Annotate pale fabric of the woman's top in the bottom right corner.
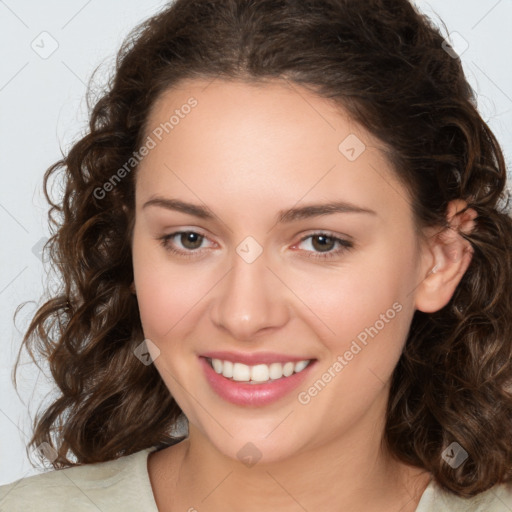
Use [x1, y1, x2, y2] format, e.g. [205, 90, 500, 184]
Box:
[416, 481, 512, 512]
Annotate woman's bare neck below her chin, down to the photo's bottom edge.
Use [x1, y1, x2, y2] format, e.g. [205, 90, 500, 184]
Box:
[155, 398, 430, 512]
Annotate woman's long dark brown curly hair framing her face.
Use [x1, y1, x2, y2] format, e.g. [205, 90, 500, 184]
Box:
[14, 0, 512, 496]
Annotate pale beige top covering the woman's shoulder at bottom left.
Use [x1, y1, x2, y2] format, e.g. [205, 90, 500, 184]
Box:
[0, 447, 157, 512]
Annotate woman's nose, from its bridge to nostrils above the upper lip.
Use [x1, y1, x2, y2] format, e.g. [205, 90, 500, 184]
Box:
[211, 247, 289, 341]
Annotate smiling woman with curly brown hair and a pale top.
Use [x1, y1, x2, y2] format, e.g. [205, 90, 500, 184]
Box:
[0, 0, 512, 512]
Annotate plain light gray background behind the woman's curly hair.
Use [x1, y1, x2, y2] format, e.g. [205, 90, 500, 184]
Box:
[0, 0, 512, 485]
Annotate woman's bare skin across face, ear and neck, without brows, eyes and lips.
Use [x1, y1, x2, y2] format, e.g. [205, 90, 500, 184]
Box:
[132, 80, 475, 512]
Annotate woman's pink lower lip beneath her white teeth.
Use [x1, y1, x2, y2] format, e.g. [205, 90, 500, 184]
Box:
[199, 357, 316, 406]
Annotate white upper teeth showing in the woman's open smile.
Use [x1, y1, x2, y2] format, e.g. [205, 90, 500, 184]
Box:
[211, 359, 310, 383]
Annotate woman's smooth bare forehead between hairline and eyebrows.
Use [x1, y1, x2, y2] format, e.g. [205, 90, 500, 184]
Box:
[137, 79, 406, 222]
